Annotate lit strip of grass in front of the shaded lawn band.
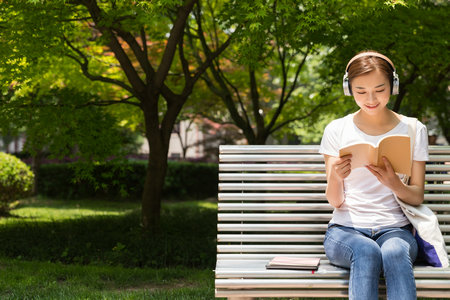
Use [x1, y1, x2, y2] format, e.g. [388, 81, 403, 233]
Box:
[0, 258, 214, 299]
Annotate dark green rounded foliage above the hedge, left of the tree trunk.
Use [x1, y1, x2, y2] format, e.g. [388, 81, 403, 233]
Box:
[0, 88, 132, 161]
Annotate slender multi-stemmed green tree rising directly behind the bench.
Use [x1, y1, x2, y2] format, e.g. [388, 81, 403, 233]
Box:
[187, 0, 408, 144]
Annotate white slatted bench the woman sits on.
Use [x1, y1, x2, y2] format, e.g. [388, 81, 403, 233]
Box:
[215, 145, 450, 299]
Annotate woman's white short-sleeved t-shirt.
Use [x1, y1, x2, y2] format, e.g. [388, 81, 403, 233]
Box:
[319, 114, 428, 228]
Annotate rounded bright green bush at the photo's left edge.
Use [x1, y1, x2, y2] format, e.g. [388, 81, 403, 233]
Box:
[0, 152, 34, 215]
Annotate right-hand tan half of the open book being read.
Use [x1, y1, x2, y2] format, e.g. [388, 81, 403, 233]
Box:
[377, 135, 411, 176]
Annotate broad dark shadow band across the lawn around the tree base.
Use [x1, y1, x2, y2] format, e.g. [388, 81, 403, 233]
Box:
[0, 201, 217, 269]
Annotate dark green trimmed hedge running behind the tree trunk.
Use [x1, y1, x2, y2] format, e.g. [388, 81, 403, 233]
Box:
[37, 161, 218, 200]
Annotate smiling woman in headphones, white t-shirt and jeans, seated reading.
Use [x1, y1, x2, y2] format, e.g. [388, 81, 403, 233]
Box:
[319, 51, 428, 300]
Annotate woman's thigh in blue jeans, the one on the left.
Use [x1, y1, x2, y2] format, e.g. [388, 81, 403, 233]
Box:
[324, 225, 381, 268]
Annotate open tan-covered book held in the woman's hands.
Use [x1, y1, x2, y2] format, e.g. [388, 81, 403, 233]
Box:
[339, 135, 411, 176]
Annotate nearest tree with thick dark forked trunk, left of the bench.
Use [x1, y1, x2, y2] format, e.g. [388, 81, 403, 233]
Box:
[0, 0, 236, 229]
